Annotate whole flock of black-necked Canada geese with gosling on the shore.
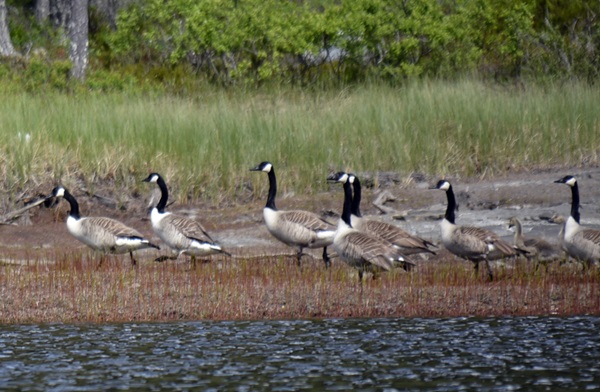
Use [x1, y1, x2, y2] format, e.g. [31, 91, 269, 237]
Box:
[42, 162, 600, 282]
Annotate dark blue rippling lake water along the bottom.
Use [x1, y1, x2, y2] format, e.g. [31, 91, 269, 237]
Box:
[0, 317, 600, 391]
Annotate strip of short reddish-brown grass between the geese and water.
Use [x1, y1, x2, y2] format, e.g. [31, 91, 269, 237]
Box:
[0, 253, 600, 324]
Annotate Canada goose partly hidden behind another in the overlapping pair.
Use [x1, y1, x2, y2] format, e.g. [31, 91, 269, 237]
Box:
[348, 173, 435, 256]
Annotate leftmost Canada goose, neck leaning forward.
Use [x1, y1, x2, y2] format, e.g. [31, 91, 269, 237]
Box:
[48, 186, 160, 266]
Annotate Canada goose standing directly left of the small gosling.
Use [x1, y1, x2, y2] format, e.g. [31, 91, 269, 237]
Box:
[433, 180, 518, 280]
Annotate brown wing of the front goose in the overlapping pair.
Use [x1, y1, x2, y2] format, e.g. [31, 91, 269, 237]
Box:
[346, 231, 400, 271]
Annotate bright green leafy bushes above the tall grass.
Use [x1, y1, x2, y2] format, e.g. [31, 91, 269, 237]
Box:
[1, 0, 600, 89]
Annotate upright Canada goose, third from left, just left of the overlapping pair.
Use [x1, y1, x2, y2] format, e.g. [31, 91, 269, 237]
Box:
[250, 162, 335, 267]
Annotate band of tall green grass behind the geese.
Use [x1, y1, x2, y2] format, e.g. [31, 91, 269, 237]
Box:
[0, 81, 600, 201]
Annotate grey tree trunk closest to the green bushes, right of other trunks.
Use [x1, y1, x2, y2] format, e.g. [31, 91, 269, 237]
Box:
[69, 0, 89, 81]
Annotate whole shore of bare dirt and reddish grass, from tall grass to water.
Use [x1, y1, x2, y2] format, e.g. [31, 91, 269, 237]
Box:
[0, 168, 600, 324]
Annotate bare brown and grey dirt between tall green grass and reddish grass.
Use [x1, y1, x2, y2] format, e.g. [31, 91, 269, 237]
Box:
[0, 167, 600, 262]
